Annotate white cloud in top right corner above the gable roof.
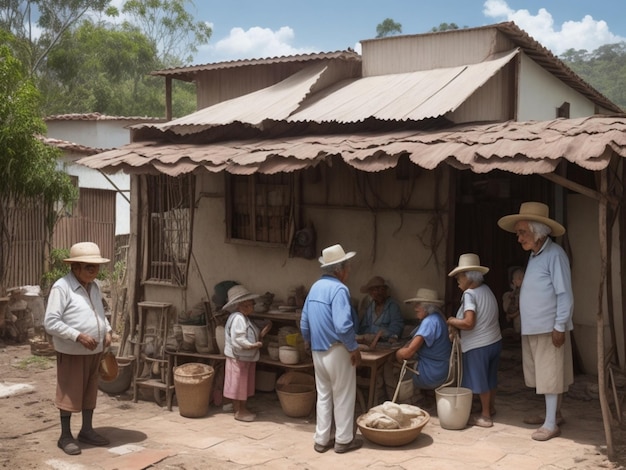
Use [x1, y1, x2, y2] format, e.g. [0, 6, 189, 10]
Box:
[483, 0, 626, 55]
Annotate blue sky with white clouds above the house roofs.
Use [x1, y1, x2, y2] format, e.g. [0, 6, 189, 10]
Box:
[191, 0, 626, 64]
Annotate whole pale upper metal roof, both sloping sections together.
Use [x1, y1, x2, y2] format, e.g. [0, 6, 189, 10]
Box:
[133, 49, 519, 135]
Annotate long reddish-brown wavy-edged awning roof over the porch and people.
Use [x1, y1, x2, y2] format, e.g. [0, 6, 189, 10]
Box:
[78, 115, 626, 176]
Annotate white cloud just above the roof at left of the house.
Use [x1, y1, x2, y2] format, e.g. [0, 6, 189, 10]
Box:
[198, 26, 317, 62]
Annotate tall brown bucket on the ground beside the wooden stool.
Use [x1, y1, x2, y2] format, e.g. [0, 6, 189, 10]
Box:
[174, 362, 215, 418]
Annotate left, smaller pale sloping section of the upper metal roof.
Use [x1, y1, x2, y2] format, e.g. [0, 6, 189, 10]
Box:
[133, 63, 328, 135]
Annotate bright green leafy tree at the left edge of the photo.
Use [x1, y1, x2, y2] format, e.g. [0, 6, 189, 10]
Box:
[0, 36, 77, 294]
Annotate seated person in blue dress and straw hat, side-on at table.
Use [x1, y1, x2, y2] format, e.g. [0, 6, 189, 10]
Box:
[396, 289, 452, 390]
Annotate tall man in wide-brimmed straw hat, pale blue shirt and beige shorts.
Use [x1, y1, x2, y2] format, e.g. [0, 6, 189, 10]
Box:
[498, 202, 574, 441]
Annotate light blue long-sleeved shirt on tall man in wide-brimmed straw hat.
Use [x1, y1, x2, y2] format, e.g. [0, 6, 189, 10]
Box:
[520, 238, 574, 335]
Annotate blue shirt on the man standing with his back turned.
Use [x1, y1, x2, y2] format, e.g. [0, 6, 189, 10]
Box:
[300, 274, 359, 351]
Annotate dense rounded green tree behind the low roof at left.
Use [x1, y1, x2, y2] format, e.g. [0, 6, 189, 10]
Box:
[41, 20, 174, 116]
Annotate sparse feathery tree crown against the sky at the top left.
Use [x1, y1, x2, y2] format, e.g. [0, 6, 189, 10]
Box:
[122, 0, 213, 67]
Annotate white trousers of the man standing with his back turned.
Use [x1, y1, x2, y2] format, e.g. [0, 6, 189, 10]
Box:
[312, 344, 356, 445]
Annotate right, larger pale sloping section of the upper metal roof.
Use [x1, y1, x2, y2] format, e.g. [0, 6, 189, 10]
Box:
[287, 49, 519, 124]
